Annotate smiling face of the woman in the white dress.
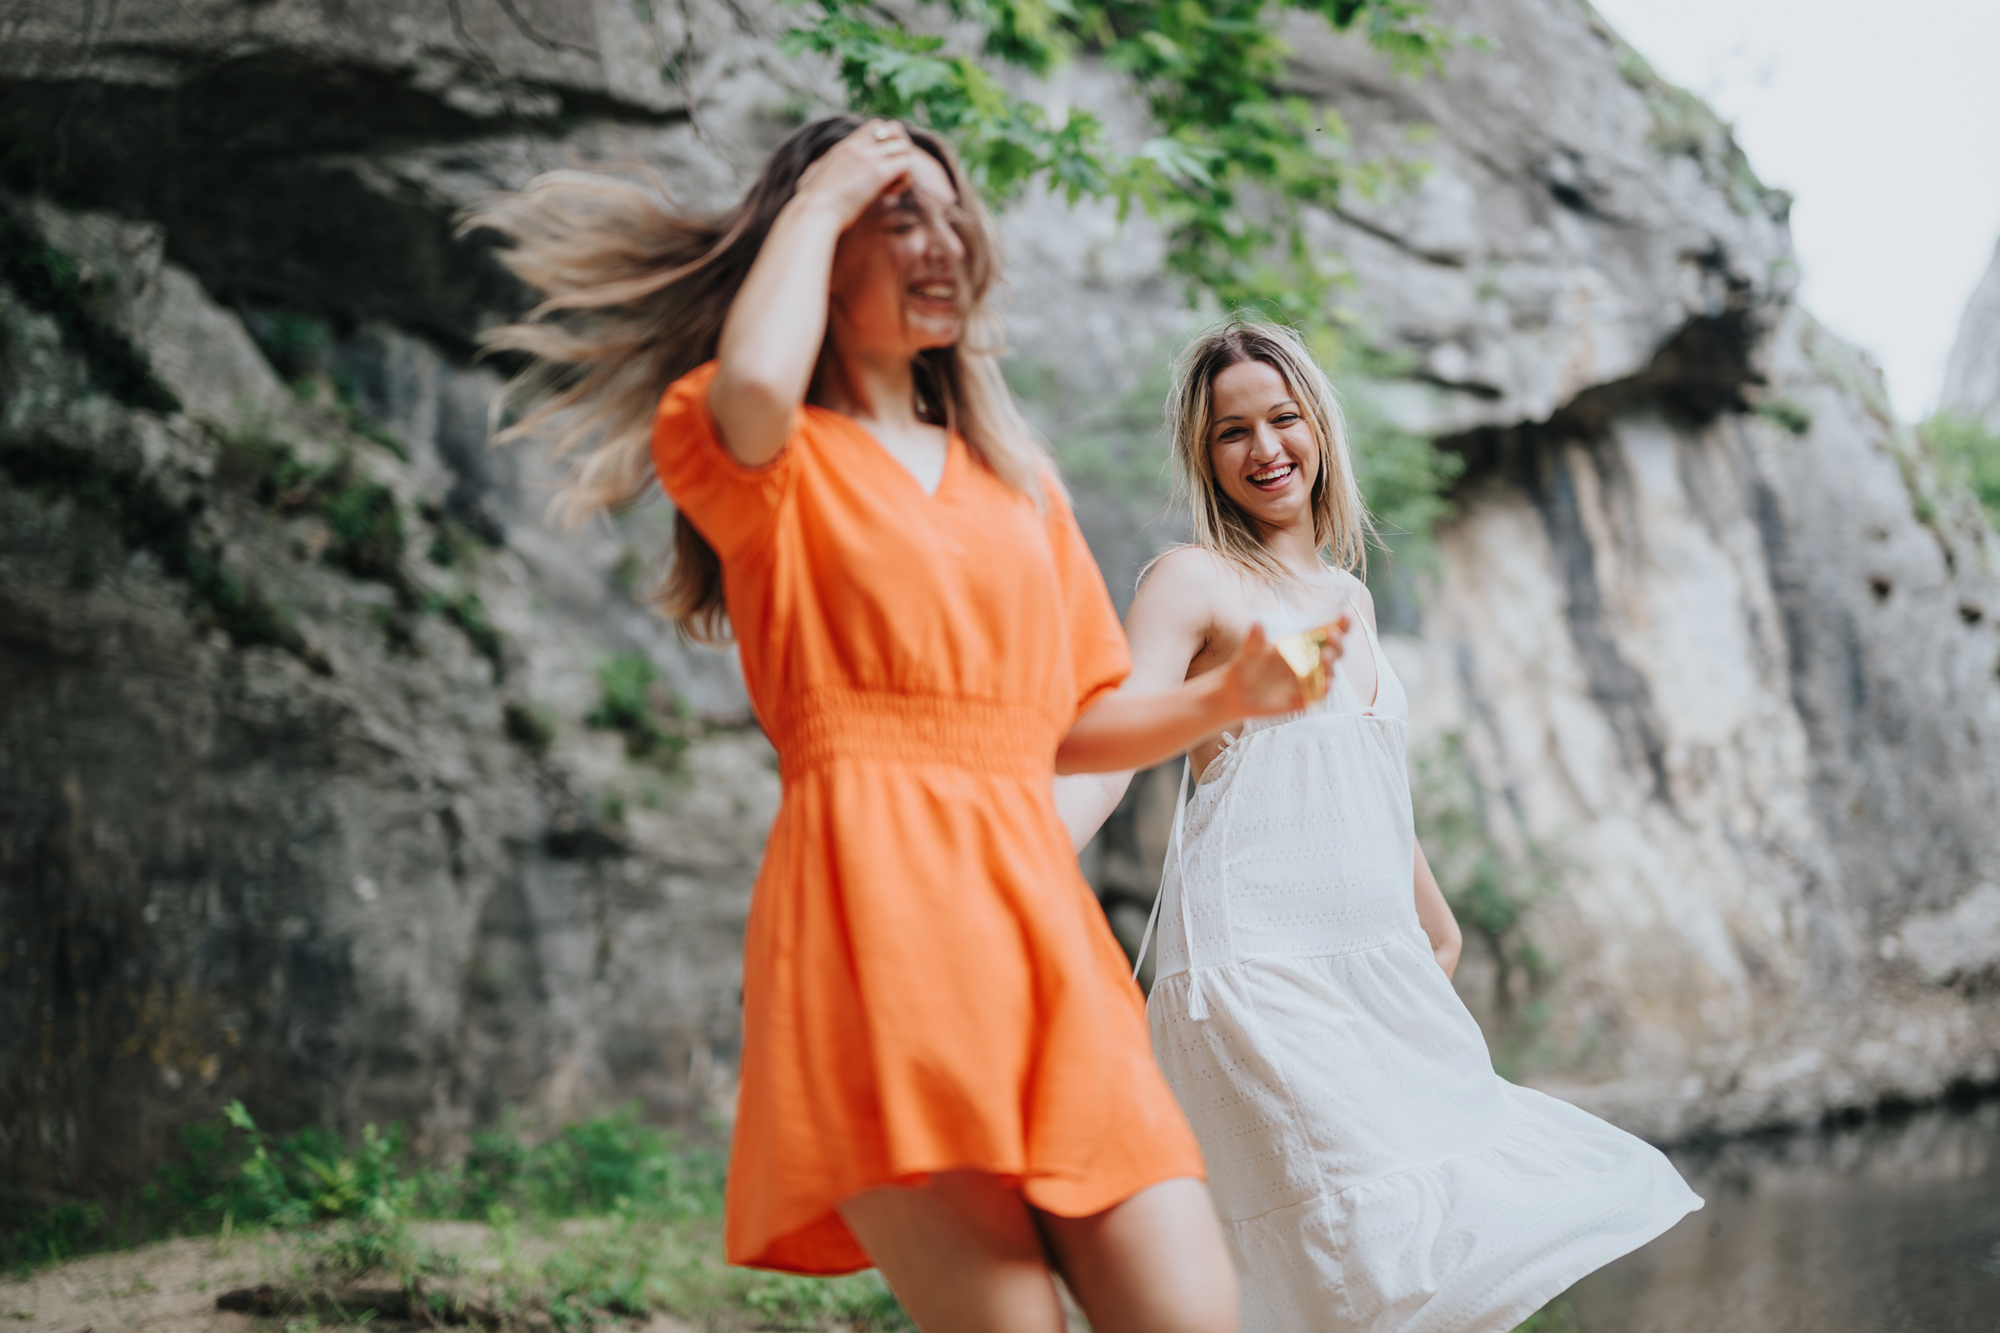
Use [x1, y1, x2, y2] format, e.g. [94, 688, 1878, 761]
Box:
[1208, 360, 1320, 534]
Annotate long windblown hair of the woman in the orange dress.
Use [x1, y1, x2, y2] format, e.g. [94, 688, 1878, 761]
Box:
[460, 116, 1054, 642]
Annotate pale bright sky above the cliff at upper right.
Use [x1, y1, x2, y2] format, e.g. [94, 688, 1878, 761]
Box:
[1596, 0, 2000, 418]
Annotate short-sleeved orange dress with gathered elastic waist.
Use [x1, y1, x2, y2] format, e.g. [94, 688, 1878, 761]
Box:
[652, 362, 1202, 1273]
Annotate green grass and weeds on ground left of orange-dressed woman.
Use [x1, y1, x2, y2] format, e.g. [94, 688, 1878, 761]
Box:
[0, 1103, 910, 1333]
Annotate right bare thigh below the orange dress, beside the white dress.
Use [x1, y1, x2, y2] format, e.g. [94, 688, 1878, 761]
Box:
[1036, 1179, 1236, 1333]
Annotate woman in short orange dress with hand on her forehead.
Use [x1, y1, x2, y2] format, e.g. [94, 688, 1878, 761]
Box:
[468, 116, 1338, 1333]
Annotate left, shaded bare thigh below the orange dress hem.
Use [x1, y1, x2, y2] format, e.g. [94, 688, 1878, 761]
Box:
[840, 1171, 1072, 1333]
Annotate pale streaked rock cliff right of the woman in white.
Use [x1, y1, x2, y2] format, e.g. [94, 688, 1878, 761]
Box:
[1308, 2, 2000, 1137]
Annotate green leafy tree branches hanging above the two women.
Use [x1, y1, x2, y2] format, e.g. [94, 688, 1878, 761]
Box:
[790, 0, 1456, 324]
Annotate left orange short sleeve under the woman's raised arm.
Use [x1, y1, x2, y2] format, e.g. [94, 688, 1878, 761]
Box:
[652, 360, 798, 560]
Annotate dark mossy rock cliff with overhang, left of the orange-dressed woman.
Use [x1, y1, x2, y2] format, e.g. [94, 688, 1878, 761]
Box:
[0, 0, 778, 1193]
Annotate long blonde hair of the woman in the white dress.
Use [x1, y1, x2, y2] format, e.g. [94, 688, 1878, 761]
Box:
[1166, 318, 1374, 578]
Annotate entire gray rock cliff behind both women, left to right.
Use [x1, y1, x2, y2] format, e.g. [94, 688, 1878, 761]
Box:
[0, 0, 2000, 1191]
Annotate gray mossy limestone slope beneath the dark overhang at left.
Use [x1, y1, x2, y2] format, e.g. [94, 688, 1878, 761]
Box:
[0, 204, 778, 1193]
